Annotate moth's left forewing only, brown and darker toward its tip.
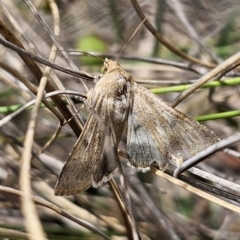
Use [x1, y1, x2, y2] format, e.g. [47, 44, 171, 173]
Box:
[54, 115, 104, 195]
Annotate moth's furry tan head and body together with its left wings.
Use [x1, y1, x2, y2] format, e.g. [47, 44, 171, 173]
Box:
[55, 60, 133, 195]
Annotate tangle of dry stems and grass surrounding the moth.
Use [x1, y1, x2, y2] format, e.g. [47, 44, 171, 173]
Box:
[0, 0, 240, 240]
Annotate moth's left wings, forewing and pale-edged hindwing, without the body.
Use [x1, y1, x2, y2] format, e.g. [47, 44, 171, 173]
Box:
[55, 110, 118, 195]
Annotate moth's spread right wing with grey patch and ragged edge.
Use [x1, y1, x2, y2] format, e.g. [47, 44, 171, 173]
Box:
[127, 83, 219, 170]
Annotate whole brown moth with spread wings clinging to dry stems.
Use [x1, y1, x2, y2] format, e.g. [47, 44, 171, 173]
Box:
[55, 59, 218, 195]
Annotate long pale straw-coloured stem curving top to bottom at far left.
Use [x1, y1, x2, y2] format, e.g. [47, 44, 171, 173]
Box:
[19, 0, 60, 240]
